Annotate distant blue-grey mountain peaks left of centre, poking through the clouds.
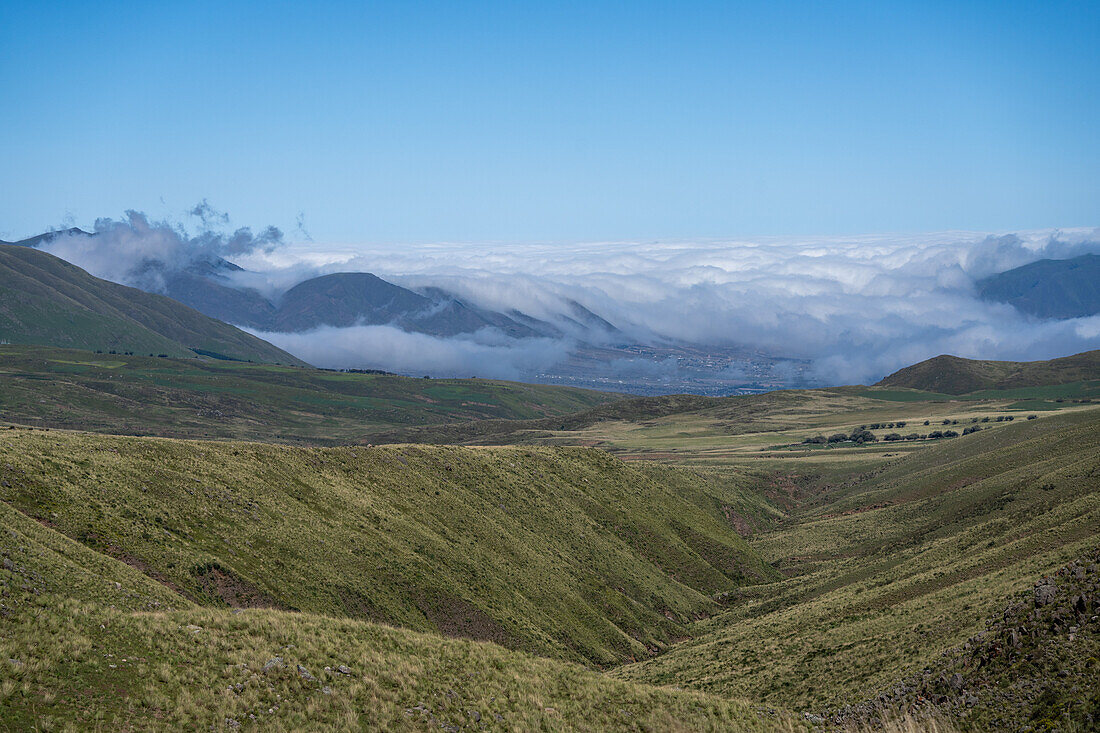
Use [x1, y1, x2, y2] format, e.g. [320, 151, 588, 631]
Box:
[2, 229, 618, 340]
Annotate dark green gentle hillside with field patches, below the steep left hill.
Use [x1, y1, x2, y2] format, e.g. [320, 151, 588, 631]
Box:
[0, 346, 620, 442]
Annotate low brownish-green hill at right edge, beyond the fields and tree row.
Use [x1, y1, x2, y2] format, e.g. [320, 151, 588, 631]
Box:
[876, 350, 1100, 394]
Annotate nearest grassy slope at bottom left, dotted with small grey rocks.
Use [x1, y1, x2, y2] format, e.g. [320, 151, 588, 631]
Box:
[0, 504, 799, 731]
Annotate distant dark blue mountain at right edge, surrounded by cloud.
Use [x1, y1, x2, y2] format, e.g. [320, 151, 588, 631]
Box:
[978, 254, 1100, 318]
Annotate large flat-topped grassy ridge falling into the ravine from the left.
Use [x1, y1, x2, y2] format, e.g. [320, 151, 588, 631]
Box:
[0, 429, 776, 665]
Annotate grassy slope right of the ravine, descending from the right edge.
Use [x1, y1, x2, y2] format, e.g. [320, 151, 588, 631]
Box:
[615, 411, 1100, 711]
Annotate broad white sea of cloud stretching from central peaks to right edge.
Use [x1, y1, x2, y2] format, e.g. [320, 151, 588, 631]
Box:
[268, 230, 1100, 384]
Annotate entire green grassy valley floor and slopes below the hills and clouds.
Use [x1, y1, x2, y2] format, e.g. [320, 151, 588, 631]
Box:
[0, 347, 1100, 731]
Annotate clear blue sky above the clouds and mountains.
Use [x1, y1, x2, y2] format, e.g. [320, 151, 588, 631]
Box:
[0, 0, 1100, 242]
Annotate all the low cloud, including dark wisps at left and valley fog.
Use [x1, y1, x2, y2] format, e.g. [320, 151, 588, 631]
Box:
[30, 203, 1100, 384]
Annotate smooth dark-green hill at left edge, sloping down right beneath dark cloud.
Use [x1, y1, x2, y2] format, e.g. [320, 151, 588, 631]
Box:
[0, 244, 303, 365]
